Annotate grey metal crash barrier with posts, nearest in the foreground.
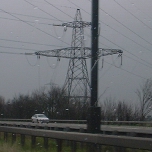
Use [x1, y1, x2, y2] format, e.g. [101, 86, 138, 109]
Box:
[0, 126, 152, 152]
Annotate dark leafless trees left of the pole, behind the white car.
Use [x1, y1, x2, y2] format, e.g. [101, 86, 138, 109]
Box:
[0, 87, 88, 119]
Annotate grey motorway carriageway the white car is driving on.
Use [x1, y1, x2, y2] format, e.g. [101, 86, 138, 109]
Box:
[0, 121, 152, 138]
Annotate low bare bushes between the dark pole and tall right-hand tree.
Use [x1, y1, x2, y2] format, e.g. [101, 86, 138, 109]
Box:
[100, 98, 141, 121]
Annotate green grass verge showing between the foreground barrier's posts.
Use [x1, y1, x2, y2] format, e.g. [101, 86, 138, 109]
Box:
[0, 133, 148, 152]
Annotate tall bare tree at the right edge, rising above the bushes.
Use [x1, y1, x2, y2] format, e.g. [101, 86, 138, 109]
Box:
[136, 79, 152, 120]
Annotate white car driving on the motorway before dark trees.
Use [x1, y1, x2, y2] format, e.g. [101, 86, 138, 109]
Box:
[31, 114, 49, 123]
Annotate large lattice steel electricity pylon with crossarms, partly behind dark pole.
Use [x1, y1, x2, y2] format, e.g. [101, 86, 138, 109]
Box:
[35, 9, 122, 102]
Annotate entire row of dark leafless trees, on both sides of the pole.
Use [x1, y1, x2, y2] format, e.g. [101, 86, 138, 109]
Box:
[0, 79, 152, 121]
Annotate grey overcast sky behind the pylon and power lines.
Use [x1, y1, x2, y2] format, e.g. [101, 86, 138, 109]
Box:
[0, 0, 152, 102]
